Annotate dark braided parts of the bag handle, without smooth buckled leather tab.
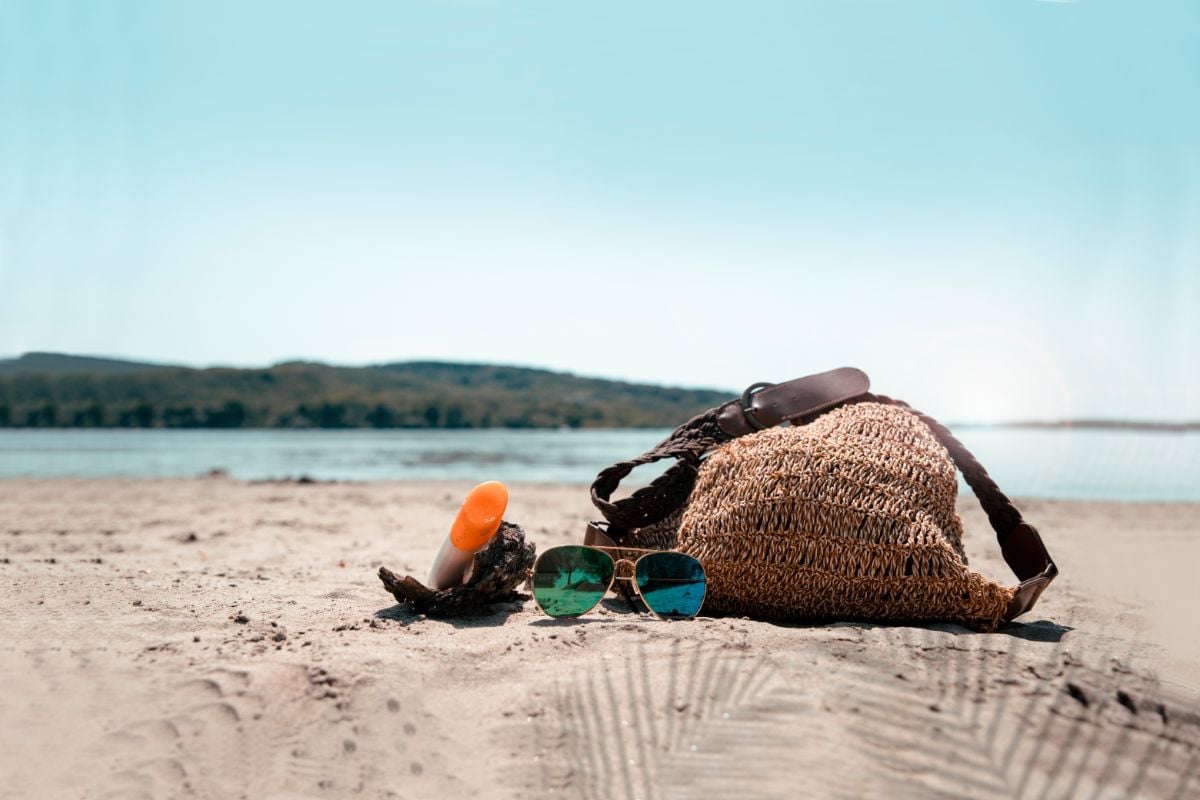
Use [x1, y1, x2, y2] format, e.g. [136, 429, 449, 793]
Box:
[592, 379, 1058, 620]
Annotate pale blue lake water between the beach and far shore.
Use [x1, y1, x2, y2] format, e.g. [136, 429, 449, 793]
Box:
[0, 428, 1200, 500]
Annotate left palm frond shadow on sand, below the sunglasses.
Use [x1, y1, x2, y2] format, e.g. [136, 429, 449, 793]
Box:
[544, 640, 864, 800]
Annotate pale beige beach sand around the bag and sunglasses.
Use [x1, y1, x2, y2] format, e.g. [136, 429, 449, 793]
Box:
[0, 477, 1200, 800]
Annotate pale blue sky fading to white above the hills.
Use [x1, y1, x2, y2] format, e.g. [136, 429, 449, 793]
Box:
[0, 0, 1200, 421]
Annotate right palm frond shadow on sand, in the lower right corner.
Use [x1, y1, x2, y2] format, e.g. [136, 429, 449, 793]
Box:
[857, 628, 1200, 800]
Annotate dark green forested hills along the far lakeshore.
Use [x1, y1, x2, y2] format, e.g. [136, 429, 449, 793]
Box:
[0, 354, 728, 428]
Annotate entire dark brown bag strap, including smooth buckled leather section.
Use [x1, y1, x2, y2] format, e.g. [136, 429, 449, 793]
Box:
[588, 367, 1058, 620]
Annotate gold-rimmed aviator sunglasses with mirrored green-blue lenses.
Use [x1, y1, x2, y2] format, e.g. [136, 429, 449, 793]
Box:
[532, 545, 707, 619]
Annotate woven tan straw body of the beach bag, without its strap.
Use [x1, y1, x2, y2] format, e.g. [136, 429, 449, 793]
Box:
[631, 403, 1013, 630]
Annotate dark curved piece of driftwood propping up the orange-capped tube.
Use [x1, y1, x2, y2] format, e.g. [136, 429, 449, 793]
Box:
[379, 522, 534, 616]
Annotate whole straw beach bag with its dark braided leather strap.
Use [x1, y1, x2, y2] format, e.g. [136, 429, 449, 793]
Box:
[587, 368, 1057, 630]
